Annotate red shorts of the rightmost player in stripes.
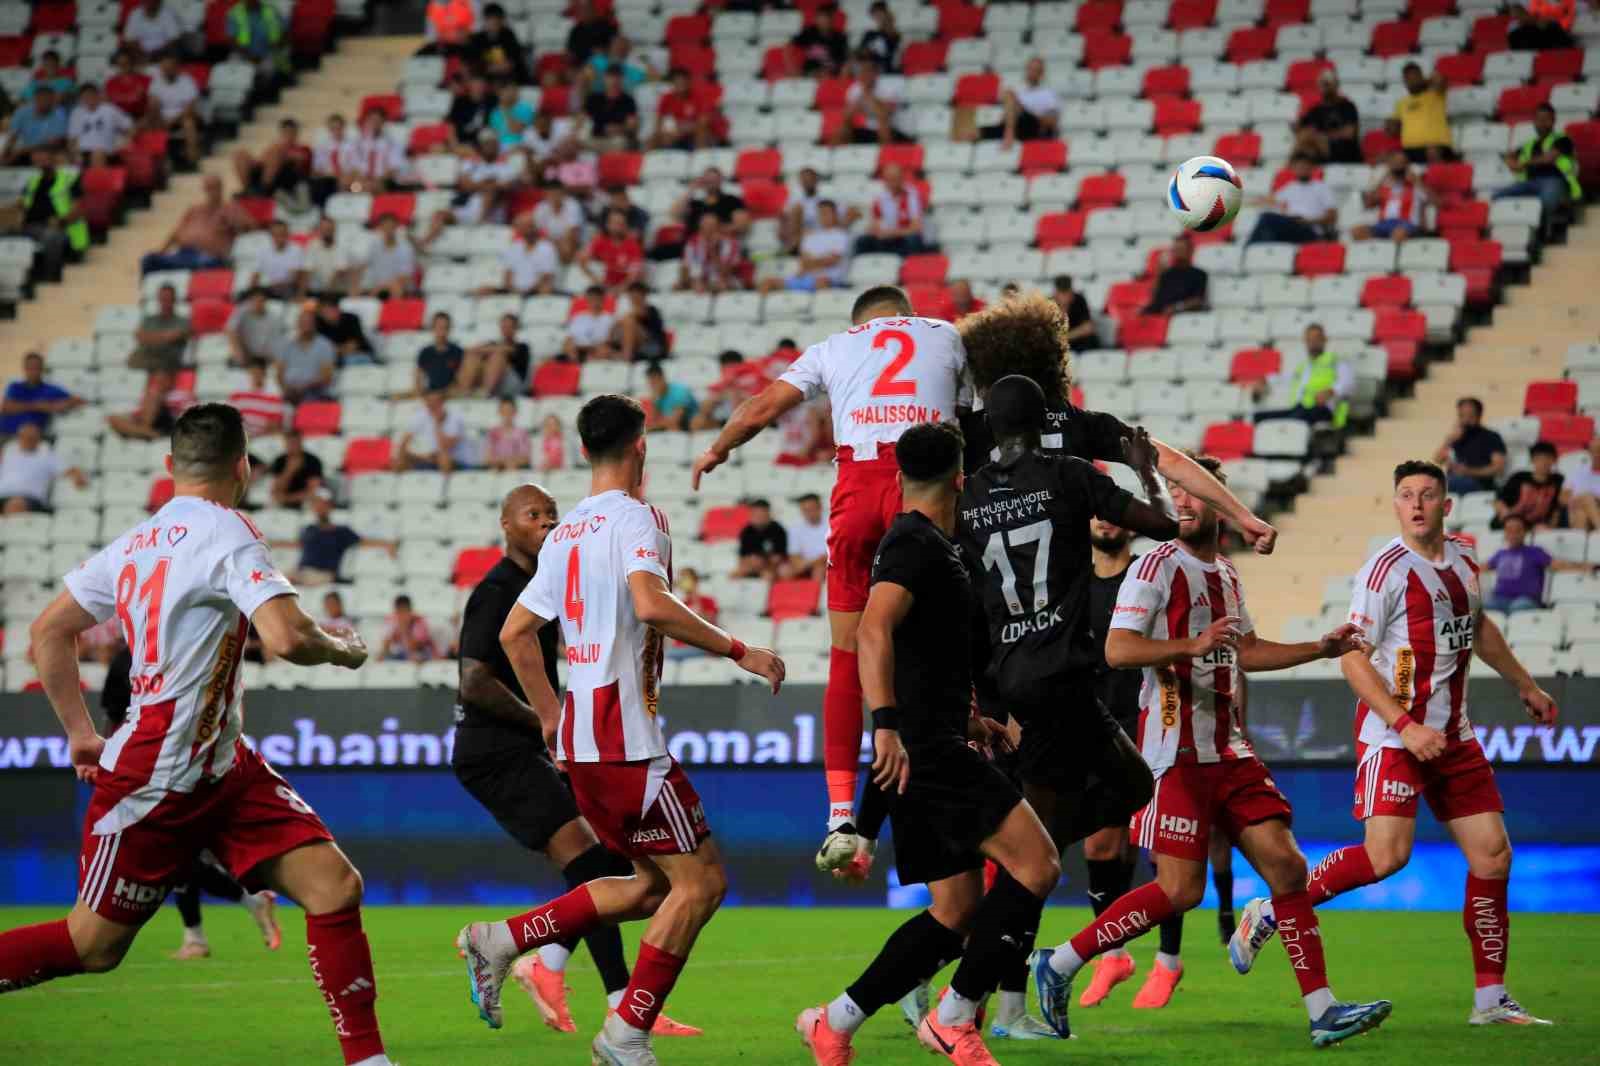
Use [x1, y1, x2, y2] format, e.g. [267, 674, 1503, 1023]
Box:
[1350, 738, 1506, 821]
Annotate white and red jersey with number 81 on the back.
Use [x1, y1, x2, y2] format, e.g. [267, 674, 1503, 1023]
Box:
[62, 496, 294, 834]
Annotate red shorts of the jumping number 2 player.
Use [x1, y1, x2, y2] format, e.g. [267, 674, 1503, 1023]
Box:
[827, 445, 901, 611]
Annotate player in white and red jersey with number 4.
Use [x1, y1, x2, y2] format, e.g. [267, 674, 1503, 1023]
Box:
[456, 395, 784, 1066]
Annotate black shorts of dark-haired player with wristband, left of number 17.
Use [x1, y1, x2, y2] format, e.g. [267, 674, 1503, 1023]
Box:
[890, 738, 1022, 885]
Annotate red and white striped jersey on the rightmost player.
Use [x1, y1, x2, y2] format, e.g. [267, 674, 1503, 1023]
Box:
[1350, 536, 1483, 747]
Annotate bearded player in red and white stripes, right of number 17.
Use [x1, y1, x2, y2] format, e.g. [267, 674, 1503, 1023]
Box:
[1034, 456, 1390, 1047]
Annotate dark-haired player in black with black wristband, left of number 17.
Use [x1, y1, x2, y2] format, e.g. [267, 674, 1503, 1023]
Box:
[795, 423, 1068, 1066]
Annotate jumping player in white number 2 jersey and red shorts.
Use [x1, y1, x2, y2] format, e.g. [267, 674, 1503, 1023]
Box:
[694, 285, 971, 869]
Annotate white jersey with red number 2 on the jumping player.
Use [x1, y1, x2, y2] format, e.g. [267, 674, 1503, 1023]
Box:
[778, 317, 971, 459]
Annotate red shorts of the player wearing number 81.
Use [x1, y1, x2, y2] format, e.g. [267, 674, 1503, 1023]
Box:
[78, 744, 333, 925]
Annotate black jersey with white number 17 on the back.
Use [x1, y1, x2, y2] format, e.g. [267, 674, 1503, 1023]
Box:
[957, 451, 1133, 696]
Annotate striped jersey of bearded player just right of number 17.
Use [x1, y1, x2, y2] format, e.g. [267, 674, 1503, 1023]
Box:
[1110, 541, 1256, 776]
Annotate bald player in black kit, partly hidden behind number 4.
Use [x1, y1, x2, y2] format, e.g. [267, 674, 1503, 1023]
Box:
[453, 485, 699, 1036]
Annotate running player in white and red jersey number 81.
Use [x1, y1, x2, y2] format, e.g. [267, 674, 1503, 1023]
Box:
[0, 403, 389, 1066]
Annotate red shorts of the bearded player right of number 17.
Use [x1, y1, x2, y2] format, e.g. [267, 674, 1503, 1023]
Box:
[1130, 759, 1293, 863]
